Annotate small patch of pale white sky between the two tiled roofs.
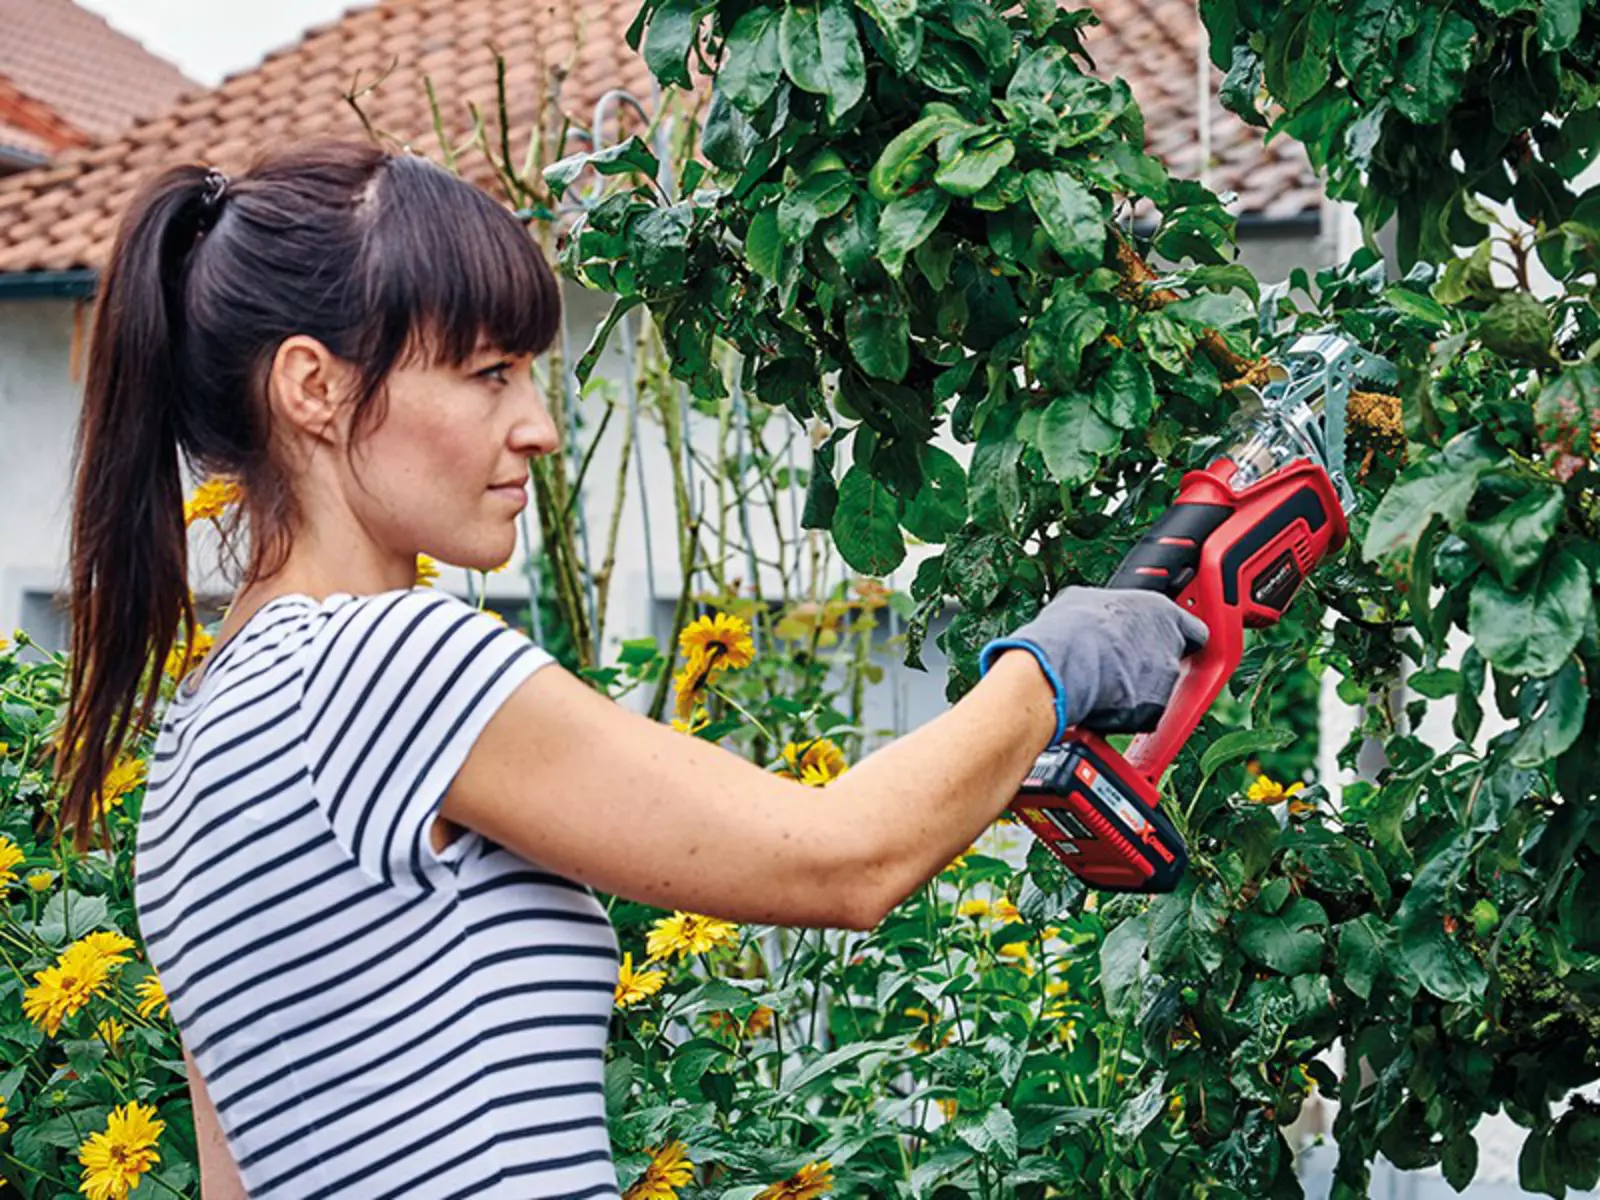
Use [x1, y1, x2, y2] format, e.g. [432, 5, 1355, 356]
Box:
[77, 0, 365, 85]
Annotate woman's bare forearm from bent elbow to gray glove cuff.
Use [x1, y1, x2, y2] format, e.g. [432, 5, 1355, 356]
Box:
[827, 650, 1056, 917]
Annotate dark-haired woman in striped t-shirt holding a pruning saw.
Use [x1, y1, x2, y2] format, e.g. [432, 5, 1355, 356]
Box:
[58, 142, 1205, 1200]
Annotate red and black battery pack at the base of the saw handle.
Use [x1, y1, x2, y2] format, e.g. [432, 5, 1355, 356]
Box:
[1010, 730, 1189, 891]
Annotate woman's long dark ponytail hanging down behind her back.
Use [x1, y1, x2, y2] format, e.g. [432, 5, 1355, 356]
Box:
[54, 166, 219, 851]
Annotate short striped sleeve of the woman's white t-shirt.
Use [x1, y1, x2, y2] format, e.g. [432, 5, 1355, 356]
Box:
[301, 589, 555, 890]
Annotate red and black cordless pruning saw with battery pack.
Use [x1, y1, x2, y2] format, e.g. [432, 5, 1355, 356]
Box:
[1010, 333, 1395, 891]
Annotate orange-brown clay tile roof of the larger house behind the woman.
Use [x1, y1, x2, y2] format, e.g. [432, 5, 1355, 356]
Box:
[0, 0, 1322, 274]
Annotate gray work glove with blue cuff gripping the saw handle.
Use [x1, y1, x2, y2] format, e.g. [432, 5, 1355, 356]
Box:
[978, 587, 1210, 746]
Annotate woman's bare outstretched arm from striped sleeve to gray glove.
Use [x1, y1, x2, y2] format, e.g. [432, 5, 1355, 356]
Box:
[440, 651, 1056, 930]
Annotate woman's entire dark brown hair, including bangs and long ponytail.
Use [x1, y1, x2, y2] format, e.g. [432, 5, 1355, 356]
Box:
[54, 141, 560, 851]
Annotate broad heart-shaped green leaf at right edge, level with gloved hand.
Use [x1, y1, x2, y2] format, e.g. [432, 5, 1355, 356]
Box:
[1467, 549, 1594, 675]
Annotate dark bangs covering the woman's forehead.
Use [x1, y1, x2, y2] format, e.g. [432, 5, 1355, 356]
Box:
[370, 155, 562, 366]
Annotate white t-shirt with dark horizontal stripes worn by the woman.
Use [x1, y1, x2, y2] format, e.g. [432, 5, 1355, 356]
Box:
[134, 590, 618, 1200]
